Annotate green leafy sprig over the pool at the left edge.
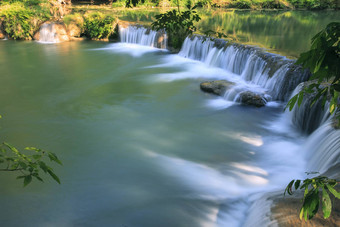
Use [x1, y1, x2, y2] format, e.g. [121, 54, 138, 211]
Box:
[0, 142, 62, 187]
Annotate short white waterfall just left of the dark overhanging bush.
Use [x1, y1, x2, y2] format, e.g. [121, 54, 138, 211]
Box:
[119, 25, 168, 49]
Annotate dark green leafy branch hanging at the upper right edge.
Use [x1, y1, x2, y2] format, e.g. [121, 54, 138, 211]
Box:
[286, 22, 340, 123]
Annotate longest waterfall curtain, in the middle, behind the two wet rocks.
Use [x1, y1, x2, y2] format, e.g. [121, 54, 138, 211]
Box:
[179, 36, 309, 101]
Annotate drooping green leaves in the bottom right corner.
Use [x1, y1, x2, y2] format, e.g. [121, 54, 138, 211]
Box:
[284, 176, 340, 221]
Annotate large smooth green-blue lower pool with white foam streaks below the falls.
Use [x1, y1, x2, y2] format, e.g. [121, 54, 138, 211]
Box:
[0, 9, 338, 227]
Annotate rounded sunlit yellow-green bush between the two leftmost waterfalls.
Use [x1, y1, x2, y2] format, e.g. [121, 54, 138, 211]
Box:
[84, 12, 115, 39]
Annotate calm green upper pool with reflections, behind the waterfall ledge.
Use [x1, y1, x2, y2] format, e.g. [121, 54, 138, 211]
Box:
[117, 9, 340, 58]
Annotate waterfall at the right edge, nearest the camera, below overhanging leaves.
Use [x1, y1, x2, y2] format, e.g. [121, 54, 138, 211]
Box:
[287, 82, 340, 174]
